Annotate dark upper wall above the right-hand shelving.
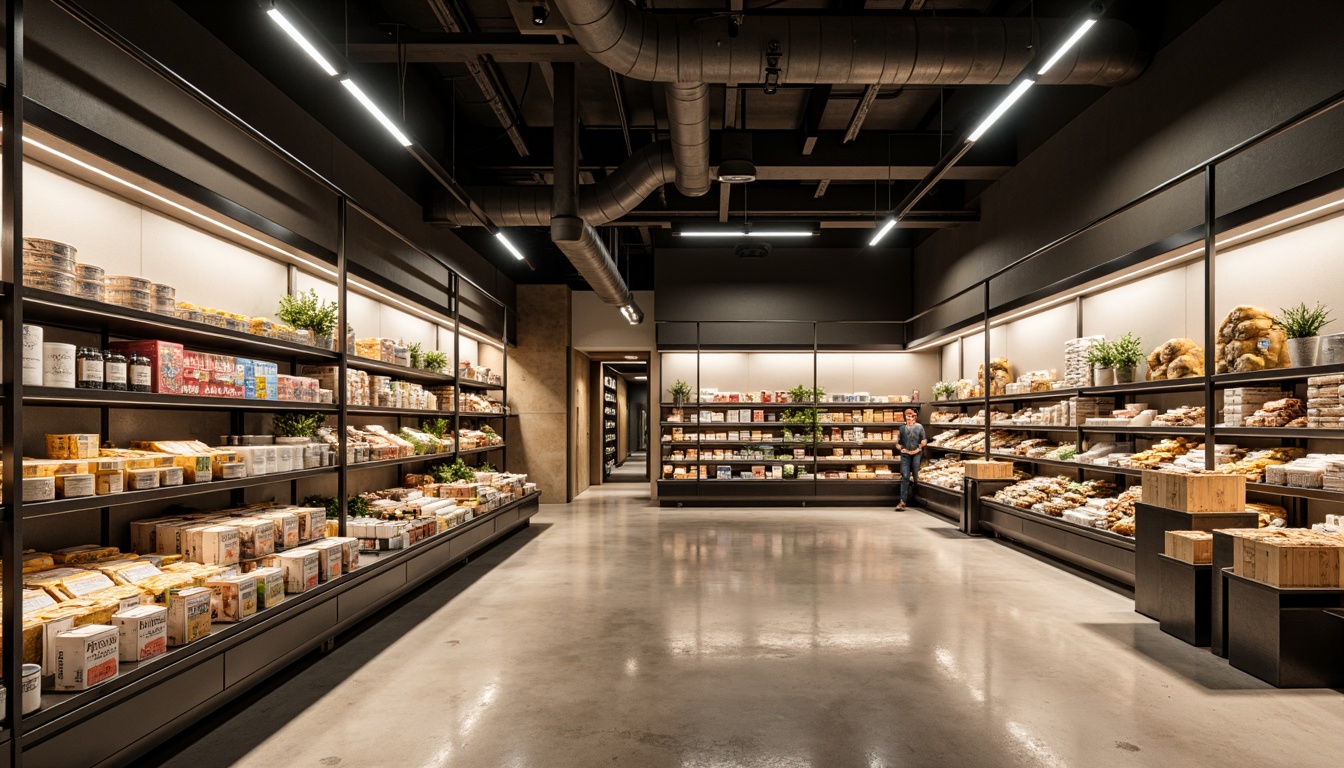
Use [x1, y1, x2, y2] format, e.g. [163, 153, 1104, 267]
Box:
[913, 0, 1344, 338]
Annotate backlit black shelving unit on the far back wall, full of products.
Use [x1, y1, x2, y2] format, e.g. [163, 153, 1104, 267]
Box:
[659, 351, 935, 504]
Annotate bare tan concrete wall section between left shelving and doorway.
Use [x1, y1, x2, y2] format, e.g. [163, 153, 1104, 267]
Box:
[508, 285, 570, 503]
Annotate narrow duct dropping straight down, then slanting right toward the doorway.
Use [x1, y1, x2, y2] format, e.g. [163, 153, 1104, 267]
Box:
[548, 63, 644, 324]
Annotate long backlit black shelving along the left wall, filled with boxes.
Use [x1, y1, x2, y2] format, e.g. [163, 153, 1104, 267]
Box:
[4, 117, 539, 761]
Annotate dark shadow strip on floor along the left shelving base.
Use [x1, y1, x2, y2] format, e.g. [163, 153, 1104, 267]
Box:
[136, 522, 554, 768]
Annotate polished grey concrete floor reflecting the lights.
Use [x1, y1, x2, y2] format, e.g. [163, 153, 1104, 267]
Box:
[156, 486, 1344, 768]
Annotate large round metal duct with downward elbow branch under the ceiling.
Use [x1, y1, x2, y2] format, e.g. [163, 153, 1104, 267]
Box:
[427, 0, 1148, 226]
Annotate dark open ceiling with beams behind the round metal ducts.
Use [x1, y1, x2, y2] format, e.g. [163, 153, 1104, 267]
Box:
[177, 0, 1216, 289]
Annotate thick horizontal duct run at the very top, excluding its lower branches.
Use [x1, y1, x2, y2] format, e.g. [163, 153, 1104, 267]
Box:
[554, 0, 1148, 86]
